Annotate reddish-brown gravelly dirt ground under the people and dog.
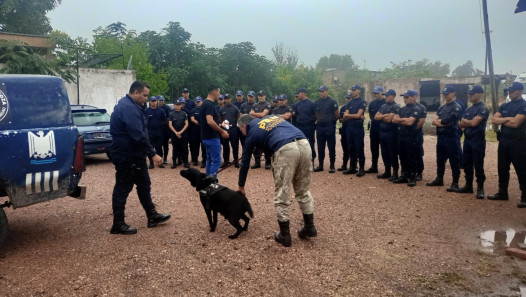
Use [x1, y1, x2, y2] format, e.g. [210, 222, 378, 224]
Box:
[0, 136, 526, 296]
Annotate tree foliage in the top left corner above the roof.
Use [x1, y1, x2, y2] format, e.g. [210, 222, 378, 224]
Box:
[0, 0, 61, 35]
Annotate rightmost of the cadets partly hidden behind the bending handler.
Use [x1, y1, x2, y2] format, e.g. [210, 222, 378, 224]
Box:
[292, 88, 316, 163]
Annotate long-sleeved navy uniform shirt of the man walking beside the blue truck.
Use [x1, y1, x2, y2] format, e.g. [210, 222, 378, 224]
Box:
[110, 95, 155, 164]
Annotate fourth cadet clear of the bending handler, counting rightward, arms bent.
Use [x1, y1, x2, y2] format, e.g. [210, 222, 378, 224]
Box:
[369, 89, 400, 181]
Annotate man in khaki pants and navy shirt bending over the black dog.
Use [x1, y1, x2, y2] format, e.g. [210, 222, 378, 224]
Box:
[237, 114, 317, 246]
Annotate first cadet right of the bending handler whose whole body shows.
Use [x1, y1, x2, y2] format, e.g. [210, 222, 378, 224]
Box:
[314, 86, 340, 173]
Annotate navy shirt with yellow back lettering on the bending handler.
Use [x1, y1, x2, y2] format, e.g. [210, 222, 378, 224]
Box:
[238, 115, 306, 187]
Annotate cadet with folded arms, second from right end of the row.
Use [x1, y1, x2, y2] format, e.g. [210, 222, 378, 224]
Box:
[456, 86, 489, 199]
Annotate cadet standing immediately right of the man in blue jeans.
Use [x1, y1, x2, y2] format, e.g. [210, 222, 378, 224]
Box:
[219, 94, 240, 168]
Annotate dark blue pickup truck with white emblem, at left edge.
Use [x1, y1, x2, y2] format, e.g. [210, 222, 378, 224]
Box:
[0, 75, 86, 246]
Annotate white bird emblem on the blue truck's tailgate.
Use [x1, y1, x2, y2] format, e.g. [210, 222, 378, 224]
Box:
[27, 130, 57, 165]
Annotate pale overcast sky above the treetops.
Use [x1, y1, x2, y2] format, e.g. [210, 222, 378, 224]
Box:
[49, 0, 526, 74]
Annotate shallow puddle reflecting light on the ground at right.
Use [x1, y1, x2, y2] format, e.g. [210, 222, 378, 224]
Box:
[480, 229, 526, 254]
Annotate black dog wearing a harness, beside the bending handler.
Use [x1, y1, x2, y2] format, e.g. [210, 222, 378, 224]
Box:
[181, 168, 254, 239]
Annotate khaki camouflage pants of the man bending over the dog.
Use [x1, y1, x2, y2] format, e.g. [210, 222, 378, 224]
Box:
[272, 139, 314, 222]
